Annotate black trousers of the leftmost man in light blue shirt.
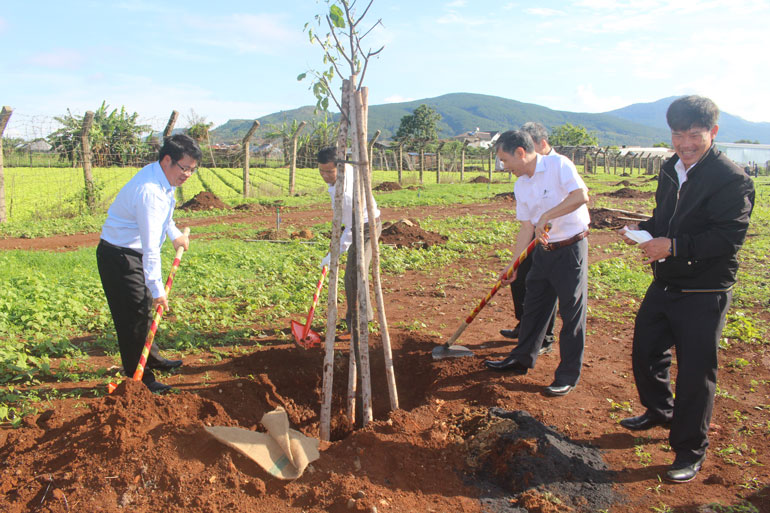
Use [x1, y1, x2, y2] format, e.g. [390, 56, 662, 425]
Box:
[96, 241, 166, 383]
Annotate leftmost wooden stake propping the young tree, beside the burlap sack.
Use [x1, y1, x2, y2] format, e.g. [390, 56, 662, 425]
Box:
[320, 80, 352, 441]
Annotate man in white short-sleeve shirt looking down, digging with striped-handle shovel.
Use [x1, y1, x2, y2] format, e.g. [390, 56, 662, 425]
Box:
[485, 130, 590, 396]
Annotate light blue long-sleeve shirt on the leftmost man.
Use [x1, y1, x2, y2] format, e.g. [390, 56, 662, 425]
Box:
[102, 162, 182, 298]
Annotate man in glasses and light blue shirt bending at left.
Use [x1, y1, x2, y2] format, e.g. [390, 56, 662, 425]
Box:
[96, 134, 202, 393]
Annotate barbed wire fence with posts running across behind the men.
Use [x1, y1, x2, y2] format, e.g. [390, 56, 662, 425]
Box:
[0, 107, 662, 222]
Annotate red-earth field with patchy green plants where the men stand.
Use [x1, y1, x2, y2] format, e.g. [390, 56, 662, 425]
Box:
[0, 173, 770, 513]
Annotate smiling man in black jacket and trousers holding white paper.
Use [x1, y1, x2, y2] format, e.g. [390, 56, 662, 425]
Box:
[620, 96, 754, 482]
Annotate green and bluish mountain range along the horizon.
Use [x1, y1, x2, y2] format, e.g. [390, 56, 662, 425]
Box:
[210, 93, 770, 146]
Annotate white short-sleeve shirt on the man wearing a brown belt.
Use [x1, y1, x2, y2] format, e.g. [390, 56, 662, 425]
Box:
[513, 153, 591, 242]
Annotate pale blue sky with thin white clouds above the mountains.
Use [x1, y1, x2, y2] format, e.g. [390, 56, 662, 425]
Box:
[0, 0, 770, 136]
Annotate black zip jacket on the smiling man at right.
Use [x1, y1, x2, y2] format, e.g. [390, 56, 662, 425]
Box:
[639, 145, 754, 292]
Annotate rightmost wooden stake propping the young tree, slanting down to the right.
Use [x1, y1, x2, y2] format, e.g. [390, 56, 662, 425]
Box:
[356, 87, 398, 410]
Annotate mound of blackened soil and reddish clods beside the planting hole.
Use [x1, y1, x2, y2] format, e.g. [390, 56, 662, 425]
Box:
[463, 408, 622, 512]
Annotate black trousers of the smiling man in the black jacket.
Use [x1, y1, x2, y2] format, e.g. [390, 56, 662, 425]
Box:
[631, 282, 732, 463]
